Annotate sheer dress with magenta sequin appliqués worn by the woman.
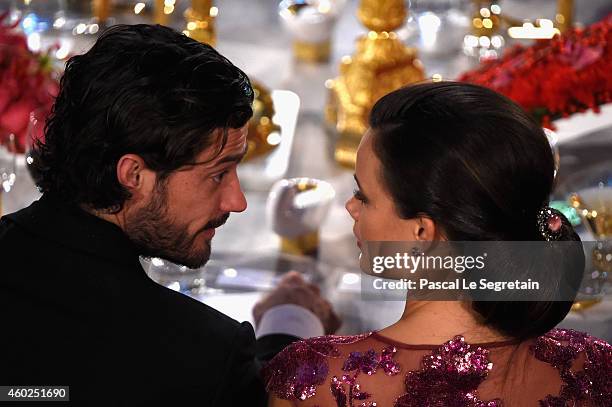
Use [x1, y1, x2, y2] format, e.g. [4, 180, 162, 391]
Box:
[263, 329, 612, 407]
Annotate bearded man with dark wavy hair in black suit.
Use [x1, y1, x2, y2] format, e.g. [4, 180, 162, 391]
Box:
[0, 25, 334, 406]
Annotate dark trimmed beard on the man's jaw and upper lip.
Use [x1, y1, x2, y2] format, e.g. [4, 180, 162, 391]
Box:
[125, 181, 229, 268]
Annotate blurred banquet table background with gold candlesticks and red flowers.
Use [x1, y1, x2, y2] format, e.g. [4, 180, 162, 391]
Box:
[0, 0, 612, 341]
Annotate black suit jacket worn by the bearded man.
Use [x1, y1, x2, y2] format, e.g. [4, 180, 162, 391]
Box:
[0, 196, 295, 407]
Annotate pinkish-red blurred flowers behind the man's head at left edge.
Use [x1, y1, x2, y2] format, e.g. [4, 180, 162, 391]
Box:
[0, 13, 59, 153]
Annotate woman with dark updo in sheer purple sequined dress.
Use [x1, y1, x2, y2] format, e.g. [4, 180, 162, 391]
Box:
[264, 82, 612, 407]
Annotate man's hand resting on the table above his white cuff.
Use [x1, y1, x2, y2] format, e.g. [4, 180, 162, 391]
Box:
[253, 271, 341, 334]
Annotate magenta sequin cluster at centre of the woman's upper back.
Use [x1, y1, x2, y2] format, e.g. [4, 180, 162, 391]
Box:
[395, 336, 501, 407]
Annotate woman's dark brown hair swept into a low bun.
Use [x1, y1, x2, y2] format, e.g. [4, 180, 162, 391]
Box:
[370, 82, 584, 339]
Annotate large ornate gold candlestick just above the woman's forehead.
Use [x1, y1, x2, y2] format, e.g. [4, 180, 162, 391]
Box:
[325, 0, 425, 168]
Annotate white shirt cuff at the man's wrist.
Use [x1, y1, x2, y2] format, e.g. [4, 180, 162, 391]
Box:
[255, 304, 325, 339]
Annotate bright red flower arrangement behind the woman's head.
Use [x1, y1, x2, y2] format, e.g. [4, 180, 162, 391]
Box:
[459, 14, 612, 128]
